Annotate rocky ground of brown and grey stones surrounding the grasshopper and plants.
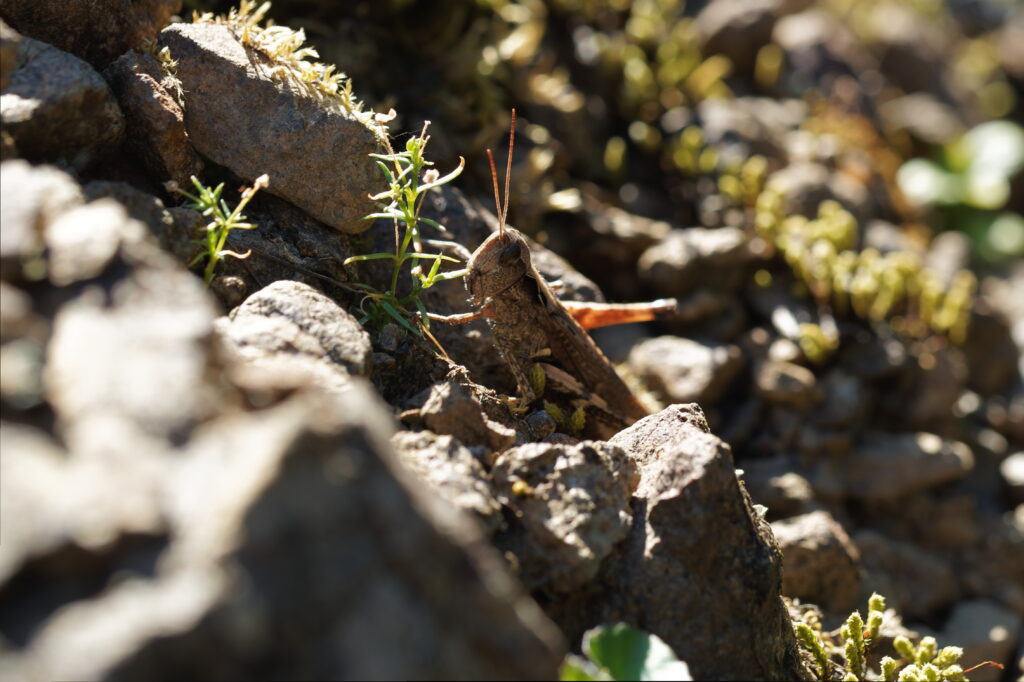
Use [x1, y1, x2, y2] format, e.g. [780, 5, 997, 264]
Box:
[0, 0, 1024, 680]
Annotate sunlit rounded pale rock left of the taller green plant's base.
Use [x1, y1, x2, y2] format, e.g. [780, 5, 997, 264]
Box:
[217, 281, 372, 391]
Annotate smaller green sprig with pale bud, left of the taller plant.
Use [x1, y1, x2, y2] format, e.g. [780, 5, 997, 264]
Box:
[165, 173, 270, 287]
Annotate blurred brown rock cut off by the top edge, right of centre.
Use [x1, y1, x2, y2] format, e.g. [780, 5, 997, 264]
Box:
[696, 0, 782, 74]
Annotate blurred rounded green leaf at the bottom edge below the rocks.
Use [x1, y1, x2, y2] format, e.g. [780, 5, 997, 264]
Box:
[558, 623, 693, 680]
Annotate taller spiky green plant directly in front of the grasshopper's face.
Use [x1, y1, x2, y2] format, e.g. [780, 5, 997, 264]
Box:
[344, 121, 466, 336]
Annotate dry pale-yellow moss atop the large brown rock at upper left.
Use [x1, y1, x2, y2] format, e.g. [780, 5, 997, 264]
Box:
[193, 0, 387, 137]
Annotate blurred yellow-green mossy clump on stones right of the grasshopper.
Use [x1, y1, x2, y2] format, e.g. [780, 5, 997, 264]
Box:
[755, 190, 977, 345]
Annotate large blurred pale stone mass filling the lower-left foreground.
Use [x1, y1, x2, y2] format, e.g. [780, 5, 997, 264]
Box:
[0, 166, 563, 680]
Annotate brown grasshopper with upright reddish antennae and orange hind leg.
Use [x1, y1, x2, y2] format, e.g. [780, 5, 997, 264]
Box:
[431, 110, 676, 438]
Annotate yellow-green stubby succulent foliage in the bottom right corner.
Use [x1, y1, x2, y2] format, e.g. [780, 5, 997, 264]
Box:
[794, 593, 967, 682]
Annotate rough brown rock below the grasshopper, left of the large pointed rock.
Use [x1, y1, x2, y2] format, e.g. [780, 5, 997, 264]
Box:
[493, 440, 637, 593]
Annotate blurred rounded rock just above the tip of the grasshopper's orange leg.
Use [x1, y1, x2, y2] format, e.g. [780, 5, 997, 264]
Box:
[637, 227, 751, 296]
